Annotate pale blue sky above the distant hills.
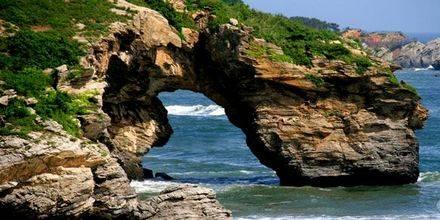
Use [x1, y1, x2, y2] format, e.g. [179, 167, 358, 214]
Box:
[243, 0, 440, 33]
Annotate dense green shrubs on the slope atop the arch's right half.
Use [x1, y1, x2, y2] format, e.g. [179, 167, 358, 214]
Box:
[182, 0, 371, 67]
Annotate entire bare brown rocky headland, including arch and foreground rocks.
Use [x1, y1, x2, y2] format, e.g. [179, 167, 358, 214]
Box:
[0, 0, 428, 219]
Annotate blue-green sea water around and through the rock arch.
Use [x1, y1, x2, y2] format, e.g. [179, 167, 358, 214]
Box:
[132, 70, 440, 219]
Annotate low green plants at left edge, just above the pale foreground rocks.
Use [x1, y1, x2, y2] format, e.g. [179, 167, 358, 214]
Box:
[0, 69, 95, 136]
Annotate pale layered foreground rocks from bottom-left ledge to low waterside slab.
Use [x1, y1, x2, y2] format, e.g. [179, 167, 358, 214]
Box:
[0, 118, 231, 219]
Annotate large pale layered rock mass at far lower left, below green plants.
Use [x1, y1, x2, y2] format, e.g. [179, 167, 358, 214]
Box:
[0, 119, 108, 218]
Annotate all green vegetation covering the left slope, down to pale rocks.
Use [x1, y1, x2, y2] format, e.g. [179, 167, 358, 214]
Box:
[0, 0, 124, 137]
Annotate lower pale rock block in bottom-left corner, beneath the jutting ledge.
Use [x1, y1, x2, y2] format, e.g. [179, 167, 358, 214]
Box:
[0, 167, 94, 218]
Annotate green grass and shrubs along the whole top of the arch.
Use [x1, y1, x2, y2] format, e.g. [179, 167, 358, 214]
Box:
[129, 0, 372, 71]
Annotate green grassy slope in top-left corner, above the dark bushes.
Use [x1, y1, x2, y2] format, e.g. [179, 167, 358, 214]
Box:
[0, 0, 126, 37]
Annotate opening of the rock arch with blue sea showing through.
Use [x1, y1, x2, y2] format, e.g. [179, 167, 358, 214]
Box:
[142, 90, 278, 185]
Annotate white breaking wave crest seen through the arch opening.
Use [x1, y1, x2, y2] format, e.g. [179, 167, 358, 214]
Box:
[165, 105, 225, 116]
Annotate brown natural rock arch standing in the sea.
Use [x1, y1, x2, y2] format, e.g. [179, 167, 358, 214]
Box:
[82, 10, 427, 185]
